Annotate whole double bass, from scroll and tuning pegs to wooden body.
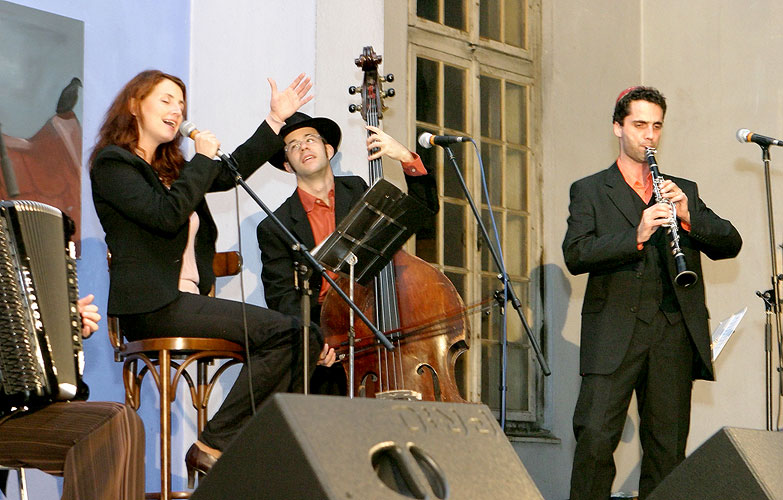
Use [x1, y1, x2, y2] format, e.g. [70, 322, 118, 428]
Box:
[321, 47, 469, 402]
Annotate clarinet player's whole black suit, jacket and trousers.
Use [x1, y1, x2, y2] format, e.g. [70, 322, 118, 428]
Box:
[563, 164, 742, 500]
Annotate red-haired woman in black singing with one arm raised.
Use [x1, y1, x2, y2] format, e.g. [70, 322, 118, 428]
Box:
[90, 70, 324, 487]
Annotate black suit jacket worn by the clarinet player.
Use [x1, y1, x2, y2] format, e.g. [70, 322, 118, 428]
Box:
[563, 163, 742, 380]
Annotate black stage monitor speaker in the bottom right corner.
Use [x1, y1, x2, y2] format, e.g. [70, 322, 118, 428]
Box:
[648, 427, 783, 500]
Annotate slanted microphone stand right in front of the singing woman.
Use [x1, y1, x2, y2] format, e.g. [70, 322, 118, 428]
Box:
[223, 155, 394, 390]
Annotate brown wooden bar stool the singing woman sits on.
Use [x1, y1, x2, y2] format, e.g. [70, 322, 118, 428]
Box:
[108, 252, 245, 500]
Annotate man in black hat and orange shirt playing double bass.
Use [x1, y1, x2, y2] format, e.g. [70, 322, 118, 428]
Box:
[256, 113, 437, 394]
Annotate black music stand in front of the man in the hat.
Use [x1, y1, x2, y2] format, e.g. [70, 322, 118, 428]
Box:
[312, 179, 434, 396]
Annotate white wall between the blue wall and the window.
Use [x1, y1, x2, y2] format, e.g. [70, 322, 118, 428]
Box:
[188, 0, 383, 488]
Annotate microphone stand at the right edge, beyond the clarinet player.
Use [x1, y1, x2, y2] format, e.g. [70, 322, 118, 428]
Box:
[757, 144, 783, 431]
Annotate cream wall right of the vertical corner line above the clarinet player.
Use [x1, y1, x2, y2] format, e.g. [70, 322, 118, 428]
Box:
[643, 0, 783, 460]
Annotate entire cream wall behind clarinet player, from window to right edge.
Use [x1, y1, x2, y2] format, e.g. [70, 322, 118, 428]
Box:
[516, 0, 783, 500]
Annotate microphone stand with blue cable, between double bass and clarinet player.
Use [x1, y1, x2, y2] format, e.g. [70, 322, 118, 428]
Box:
[443, 139, 552, 430]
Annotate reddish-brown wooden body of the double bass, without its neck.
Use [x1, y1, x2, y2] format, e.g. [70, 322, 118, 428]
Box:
[321, 251, 469, 402]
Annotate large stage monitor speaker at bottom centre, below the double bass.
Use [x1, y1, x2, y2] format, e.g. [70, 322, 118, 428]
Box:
[192, 394, 543, 500]
